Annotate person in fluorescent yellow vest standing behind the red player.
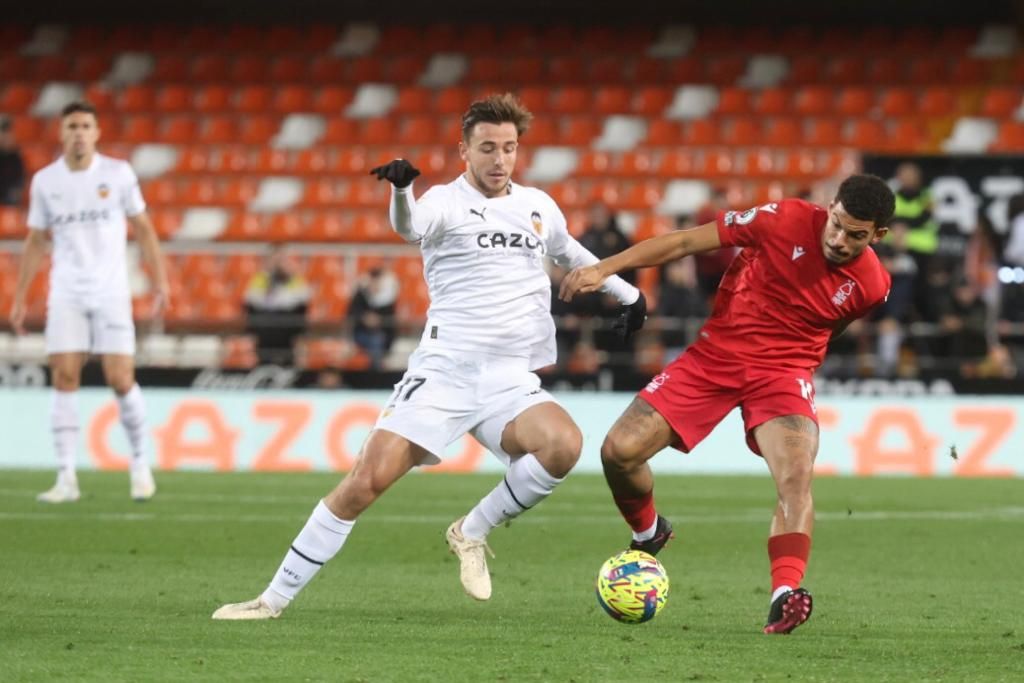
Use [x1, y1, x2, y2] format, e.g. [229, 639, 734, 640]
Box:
[890, 162, 940, 321]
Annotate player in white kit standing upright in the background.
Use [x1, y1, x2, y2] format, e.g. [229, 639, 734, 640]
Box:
[10, 102, 169, 503]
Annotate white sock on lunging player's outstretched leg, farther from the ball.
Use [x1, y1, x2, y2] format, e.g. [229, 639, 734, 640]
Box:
[262, 501, 355, 610]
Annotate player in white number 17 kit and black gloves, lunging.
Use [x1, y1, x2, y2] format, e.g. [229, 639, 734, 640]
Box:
[213, 94, 646, 620]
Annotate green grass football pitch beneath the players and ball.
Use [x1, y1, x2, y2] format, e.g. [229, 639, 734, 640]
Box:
[0, 471, 1024, 681]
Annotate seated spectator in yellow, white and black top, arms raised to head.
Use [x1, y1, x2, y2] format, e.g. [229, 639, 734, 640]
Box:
[245, 245, 309, 366]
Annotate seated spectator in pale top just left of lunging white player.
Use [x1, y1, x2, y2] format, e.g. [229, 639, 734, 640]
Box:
[348, 266, 398, 370]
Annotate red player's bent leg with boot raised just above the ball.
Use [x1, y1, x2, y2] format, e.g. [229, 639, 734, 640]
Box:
[601, 398, 681, 555]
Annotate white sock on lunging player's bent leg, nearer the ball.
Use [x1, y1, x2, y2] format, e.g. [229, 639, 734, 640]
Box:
[462, 453, 562, 539]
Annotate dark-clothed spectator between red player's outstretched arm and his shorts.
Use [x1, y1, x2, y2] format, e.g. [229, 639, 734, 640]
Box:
[653, 257, 708, 366]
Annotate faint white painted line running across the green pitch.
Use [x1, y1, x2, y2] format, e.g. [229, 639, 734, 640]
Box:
[0, 504, 1024, 525]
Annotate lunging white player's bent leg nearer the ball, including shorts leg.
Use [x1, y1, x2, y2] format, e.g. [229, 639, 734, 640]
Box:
[454, 397, 583, 600]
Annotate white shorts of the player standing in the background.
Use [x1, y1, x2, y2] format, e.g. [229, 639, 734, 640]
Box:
[46, 297, 135, 355]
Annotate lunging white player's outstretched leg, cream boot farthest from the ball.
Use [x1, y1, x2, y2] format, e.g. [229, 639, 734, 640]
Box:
[213, 429, 431, 620]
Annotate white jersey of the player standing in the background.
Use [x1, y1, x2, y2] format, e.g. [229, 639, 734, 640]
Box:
[29, 154, 145, 299]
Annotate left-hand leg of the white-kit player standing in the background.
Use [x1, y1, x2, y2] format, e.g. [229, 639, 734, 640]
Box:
[37, 352, 86, 503]
